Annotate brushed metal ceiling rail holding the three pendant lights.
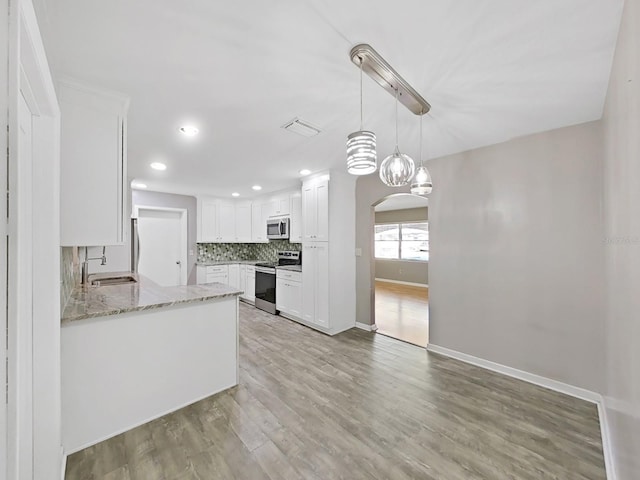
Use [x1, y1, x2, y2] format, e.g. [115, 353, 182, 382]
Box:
[350, 43, 431, 115]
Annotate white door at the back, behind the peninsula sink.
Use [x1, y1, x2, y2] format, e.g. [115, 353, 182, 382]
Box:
[138, 208, 187, 287]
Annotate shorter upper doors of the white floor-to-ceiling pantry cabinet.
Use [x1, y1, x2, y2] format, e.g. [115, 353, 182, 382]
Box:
[302, 179, 329, 242]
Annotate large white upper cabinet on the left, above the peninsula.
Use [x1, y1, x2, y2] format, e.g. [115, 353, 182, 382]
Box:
[58, 80, 129, 246]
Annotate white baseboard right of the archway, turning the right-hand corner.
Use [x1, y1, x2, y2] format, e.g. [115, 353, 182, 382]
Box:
[427, 344, 617, 480]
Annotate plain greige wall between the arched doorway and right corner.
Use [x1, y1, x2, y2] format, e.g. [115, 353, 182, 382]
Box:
[428, 122, 604, 391]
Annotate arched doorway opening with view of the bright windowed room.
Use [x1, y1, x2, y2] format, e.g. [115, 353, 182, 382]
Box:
[373, 194, 429, 347]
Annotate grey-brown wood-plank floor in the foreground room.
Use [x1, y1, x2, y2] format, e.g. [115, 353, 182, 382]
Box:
[66, 305, 605, 480]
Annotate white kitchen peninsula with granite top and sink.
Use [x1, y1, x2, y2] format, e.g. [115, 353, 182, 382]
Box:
[61, 276, 242, 454]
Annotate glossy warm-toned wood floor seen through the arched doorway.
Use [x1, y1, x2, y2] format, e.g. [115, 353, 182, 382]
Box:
[376, 280, 429, 347]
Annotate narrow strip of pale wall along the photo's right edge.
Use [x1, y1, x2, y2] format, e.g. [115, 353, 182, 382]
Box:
[603, 0, 640, 480]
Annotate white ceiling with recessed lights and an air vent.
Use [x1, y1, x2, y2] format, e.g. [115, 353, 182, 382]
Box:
[34, 0, 623, 198]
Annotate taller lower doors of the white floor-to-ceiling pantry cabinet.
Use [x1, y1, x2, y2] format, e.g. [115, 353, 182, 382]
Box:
[302, 242, 329, 328]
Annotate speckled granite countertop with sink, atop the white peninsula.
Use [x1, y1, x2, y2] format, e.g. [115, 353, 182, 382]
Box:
[61, 272, 242, 325]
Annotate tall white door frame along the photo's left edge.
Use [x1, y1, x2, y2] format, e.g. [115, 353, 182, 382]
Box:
[0, 0, 64, 480]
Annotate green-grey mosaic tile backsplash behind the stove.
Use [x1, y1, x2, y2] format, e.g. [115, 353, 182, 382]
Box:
[198, 240, 302, 262]
